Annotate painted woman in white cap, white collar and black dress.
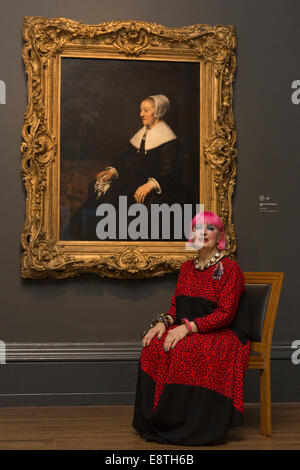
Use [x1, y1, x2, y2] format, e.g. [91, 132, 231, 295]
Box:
[71, 95, 185, 240]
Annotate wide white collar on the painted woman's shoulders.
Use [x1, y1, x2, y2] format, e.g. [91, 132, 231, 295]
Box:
[130, 121, 177, 150]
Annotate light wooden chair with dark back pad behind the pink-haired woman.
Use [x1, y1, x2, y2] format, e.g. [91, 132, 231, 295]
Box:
[244, 272, 284, 436]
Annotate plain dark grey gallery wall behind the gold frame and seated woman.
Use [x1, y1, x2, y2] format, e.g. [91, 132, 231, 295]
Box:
[0, 0, 300, 404]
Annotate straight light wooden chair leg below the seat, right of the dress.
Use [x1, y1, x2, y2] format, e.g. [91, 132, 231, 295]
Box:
[260, 363, 272, 436]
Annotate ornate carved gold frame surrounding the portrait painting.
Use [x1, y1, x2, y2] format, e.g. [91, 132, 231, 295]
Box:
[21, 17, 237, 279]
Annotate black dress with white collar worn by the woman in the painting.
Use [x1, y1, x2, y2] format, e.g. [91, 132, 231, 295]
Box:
[70, 121, 186, 240]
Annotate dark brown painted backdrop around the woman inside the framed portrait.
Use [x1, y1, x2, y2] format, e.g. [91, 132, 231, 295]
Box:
[60, 57, 200, 240]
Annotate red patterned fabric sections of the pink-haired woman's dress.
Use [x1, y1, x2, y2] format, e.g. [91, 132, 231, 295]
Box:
[140, 258, 250, 413]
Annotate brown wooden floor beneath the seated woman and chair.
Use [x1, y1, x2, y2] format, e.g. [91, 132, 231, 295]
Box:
[0, 403, 300, 450]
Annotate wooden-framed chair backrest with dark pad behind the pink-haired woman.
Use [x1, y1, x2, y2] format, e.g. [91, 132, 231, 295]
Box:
[244, 272, 284, 356]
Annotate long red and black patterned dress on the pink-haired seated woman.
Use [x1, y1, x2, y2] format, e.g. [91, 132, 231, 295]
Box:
[132, 257, 250, 445]
